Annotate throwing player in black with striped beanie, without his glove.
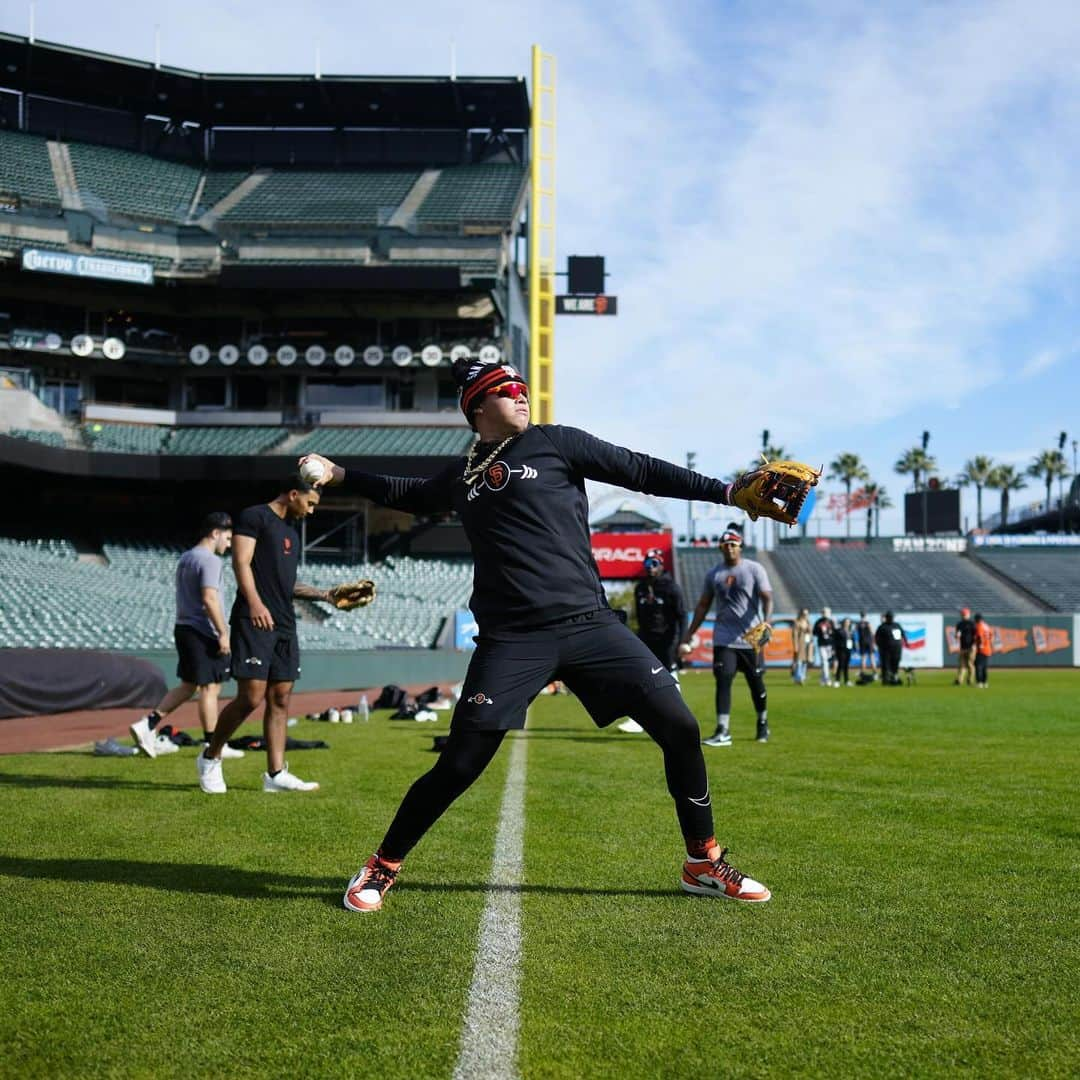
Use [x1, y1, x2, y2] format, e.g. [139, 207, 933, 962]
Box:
[301, 362, 770, 912]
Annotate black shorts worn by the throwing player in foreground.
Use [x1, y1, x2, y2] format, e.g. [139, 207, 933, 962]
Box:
[451, 609, 676, 731]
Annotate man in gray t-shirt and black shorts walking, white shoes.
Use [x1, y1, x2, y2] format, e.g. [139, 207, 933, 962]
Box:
[131, 511, 244, 757]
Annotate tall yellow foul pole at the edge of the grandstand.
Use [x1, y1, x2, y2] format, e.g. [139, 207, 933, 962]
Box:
[529, 45, 555, 423]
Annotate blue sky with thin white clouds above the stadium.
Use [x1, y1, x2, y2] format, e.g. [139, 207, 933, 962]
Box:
[10, 0, 1080, 535]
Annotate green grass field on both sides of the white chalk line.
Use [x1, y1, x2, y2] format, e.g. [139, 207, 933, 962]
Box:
[0, 671, 1080, 1078]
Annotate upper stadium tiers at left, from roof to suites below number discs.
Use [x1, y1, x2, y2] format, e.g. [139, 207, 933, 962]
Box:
[0, 35, 529, 449]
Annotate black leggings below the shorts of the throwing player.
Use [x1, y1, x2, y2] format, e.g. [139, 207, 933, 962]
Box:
[379, 686, 713, 860]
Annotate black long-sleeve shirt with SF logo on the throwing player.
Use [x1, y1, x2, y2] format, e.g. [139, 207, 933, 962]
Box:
[349, 424, 727, 635]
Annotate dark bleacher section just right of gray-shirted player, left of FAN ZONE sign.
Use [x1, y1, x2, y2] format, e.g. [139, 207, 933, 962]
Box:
[771, 545, 1041, 615]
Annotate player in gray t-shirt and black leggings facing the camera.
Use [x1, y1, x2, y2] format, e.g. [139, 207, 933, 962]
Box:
[680, 522, 772, 746]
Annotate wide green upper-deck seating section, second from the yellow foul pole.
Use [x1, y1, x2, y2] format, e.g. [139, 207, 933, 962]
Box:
[221, 170, 420, 227]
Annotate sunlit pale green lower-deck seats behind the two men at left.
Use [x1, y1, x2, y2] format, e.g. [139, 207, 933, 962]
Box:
[0, 538, 472, 650]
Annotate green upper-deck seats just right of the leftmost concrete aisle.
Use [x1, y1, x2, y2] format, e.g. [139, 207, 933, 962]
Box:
[68, 143, 201, 221]
